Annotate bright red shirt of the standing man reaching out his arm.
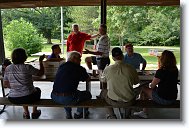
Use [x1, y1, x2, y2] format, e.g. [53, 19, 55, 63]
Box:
[67, 32, 91, 55]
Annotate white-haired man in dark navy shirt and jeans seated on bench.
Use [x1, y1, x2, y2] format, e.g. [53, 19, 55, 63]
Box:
[51, 51, 92, 119]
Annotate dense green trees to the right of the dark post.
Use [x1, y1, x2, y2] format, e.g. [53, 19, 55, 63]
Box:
[107, 6, 180, 46]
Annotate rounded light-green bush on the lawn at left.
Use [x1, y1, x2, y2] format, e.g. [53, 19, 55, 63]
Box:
[4, 19, 42, 55]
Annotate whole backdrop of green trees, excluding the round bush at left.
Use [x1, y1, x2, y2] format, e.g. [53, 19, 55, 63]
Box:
[2, 6, 180, 46]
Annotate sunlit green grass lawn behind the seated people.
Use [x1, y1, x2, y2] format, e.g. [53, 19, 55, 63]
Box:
[5, 42, 180, 69]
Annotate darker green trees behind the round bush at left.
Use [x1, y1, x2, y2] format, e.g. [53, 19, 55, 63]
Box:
[2, 7, 71, 43]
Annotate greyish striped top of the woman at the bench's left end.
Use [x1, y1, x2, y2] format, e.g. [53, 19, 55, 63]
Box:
[4, 64, 39, 97]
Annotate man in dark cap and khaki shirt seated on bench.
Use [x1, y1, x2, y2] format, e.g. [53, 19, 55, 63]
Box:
[101, 47, 139, 119]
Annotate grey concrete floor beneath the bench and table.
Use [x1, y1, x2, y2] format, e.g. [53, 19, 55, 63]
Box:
[0, 82, 182, 121]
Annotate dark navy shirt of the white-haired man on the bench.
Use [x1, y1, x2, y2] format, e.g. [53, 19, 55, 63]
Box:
[53, 61, 89, 93]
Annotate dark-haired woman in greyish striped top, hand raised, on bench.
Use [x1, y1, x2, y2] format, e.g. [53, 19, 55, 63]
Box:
[4, 48, 45, 119]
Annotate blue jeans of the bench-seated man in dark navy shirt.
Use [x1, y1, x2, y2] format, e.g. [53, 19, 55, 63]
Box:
[51, 90, 92, 115]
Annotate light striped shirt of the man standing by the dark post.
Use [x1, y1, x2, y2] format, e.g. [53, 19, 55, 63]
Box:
[96, 35, 110, 58]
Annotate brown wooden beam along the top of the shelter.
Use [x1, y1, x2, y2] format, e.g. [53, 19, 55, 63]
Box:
[0, 0, 180, 9]
